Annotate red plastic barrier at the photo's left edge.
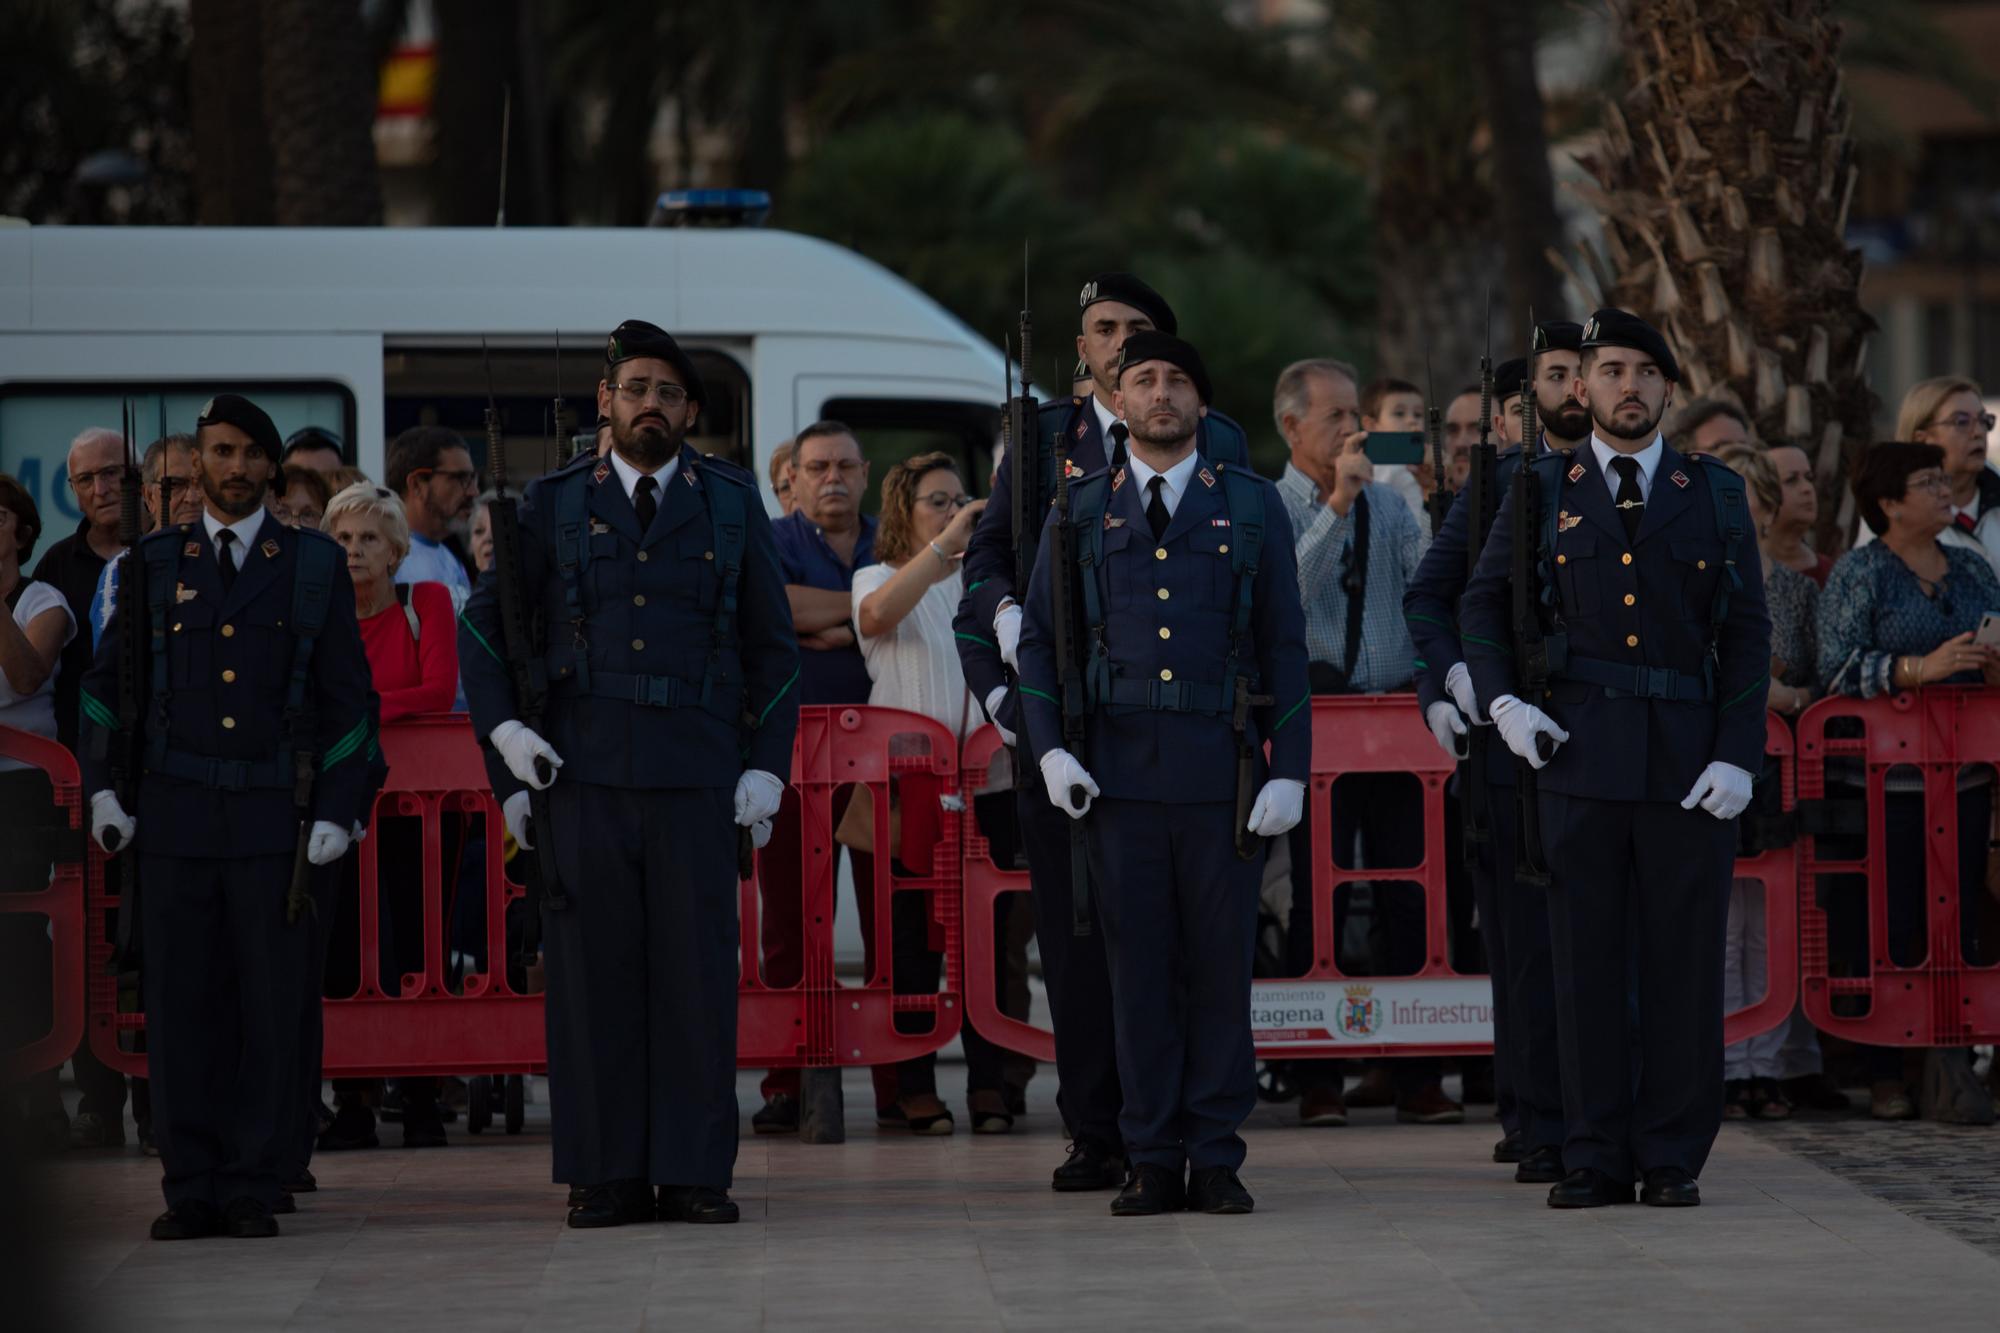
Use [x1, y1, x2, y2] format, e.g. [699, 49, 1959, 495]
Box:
[0, 727, 91, 1079]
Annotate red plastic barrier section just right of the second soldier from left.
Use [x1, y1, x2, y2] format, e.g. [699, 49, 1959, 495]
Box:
[752, 705, 964, 1067]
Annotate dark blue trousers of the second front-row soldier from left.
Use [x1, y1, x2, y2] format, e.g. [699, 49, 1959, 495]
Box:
[542, 781, 738, 1189]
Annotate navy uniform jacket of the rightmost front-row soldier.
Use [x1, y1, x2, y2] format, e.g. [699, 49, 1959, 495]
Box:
[1458, 446, 1770, 801]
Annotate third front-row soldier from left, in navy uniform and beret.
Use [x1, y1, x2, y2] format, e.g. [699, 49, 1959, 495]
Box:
[1020, 332, 1312, 1215]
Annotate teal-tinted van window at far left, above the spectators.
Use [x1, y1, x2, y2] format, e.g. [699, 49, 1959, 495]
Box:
[0, 380, 354, 538]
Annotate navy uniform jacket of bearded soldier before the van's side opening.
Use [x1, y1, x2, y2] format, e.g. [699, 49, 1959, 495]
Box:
[458, 446, 798, 801]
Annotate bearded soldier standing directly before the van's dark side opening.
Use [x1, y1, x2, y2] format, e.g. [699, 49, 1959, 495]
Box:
[458, 320, 798, 1227]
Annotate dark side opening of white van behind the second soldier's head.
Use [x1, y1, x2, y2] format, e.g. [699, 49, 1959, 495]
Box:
[382, 336, 750, 488]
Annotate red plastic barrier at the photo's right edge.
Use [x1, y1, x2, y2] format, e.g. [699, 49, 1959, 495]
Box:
[1798, 687, 2000, 1047]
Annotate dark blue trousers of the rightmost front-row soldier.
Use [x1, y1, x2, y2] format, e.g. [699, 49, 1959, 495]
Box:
[1540, 793, 1736, 1181]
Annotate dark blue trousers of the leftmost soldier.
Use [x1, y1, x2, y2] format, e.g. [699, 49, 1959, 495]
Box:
[140, 855, 322, 1207]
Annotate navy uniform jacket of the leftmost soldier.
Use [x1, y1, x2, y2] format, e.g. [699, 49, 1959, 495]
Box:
[78, 516, 380, 859]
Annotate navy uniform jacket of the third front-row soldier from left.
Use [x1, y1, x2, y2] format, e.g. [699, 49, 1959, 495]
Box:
[1020, 458, 1312, 805]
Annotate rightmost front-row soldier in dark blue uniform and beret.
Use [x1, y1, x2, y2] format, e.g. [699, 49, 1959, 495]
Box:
[1458, 310, 1770, 1207]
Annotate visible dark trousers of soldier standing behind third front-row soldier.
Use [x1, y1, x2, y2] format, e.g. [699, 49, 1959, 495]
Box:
[1014, 775, 1124, 1153]
